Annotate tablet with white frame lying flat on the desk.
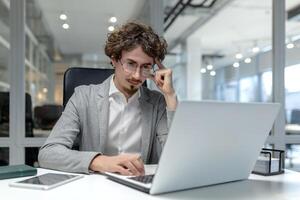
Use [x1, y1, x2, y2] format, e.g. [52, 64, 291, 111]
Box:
[9, 173, 83, 190]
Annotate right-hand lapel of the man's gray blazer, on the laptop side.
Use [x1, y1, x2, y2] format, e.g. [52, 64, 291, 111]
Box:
[139, 88, 153, 163]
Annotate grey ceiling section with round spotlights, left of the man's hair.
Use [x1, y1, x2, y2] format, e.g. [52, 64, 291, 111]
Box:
[36, 0, 145, 54]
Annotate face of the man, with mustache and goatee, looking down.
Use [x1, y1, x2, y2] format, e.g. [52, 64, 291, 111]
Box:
[111, 46, 154, 97]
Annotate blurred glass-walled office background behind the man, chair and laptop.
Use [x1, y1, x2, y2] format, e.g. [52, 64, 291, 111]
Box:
[0, 0, 300, 171]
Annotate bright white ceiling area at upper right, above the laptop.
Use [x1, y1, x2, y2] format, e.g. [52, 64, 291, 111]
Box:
[165, 0, 300, 67]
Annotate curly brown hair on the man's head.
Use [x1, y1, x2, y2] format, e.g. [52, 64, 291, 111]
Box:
[105, 22, 168, 61]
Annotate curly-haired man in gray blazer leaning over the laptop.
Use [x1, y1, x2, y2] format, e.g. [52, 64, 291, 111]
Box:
[39, 22, 177, 175]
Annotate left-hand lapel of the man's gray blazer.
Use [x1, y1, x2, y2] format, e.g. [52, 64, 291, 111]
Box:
[96, 76, 112, 152]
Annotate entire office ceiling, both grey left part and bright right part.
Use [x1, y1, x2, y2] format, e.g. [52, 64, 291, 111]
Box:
[36, 0, 300, 66]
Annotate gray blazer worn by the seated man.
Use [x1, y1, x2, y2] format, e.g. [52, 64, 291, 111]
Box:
[38, 76, 174, 173]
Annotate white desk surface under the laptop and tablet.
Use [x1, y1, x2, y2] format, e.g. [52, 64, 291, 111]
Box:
[0, 169, 300, 200]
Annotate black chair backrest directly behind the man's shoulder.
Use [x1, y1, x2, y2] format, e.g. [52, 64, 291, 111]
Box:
[63, 67, 115, 107]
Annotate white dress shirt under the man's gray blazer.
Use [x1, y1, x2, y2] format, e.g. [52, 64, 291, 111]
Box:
[104, 78, 142, 155]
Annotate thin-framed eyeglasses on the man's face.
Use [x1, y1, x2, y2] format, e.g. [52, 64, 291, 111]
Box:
[120, 60, 154, 78]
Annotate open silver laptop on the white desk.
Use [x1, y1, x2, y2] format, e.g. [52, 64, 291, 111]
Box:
[105, 101, 280, 194]
